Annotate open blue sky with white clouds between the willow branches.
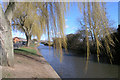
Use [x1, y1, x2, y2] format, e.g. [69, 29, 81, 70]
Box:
[7, 2, 120, 40]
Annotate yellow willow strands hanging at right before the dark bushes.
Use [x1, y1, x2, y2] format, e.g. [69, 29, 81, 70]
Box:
[79, 2, 114, 63]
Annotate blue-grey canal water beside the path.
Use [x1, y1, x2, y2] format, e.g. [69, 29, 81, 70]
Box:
[38, 44, 118, 78]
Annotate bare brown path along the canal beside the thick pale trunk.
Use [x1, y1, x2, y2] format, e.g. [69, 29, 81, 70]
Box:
[2, 54, 60, 78]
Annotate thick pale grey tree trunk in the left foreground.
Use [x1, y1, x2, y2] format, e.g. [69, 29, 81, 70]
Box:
[0, 2, 15, 67]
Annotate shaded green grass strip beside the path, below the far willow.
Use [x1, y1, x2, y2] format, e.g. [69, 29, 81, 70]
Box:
[14, 48, 37, 55]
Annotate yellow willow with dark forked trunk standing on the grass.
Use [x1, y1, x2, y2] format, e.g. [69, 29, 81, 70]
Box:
[12, 2, 43, 47]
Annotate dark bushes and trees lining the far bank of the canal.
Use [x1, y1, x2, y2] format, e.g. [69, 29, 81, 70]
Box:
[53, 25, 120, 65]
